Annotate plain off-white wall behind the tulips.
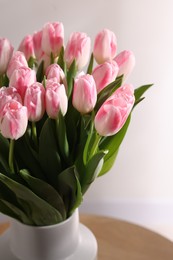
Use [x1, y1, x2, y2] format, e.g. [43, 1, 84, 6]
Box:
[0, 0, 173, 230]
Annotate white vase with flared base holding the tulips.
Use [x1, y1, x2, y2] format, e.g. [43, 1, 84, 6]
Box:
[9, 210, 97, 260]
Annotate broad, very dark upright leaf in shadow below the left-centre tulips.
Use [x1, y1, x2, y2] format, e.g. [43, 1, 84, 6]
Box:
[39, 118, 62, 187]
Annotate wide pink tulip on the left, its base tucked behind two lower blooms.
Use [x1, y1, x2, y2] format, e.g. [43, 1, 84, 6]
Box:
[9, 67, 36, 99]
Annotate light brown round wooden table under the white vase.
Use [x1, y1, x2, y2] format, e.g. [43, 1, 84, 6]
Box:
[0, 215, 173, 260]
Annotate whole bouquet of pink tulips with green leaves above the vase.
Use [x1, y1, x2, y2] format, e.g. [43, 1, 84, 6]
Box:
[0, 22, 151, 226]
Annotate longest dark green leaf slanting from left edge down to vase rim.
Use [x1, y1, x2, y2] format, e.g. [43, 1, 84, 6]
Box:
[0, 173, 62, 226]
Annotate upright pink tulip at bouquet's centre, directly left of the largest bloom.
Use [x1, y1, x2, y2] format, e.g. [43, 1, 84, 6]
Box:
[72, 74, 97, 114]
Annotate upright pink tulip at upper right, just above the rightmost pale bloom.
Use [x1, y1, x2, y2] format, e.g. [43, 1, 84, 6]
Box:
[93, 29, 117, 64]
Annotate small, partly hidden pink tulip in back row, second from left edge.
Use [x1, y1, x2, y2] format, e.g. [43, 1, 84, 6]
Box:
[18, 35, 35, 61]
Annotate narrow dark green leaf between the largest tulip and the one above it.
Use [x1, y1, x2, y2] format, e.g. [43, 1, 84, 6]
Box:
[95, 76, 123, 112]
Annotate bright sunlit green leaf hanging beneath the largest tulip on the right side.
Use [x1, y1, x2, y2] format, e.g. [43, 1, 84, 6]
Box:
[99, 115, 131, 176]
